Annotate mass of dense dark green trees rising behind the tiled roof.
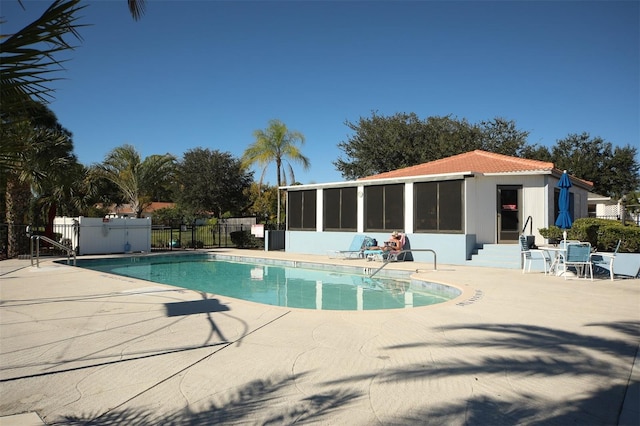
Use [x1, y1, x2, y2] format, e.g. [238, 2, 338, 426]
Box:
[334, 112, 640, 198]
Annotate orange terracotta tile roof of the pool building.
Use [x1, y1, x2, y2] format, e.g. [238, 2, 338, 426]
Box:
[359, 150, 554, 180]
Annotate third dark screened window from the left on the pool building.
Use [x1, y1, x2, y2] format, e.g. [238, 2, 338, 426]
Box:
[364, 184, 404, 231]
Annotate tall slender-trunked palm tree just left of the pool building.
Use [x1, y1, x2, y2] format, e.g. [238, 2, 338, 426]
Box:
[242, 120, 310, 226]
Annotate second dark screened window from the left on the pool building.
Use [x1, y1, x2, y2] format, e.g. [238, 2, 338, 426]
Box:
[322, 188, 358, 231]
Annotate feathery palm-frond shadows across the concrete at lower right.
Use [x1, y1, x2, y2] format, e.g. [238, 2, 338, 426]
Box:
[326, 322, 640, 425]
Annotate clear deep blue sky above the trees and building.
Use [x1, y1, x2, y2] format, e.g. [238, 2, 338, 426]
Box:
[0, 0, 640, 183]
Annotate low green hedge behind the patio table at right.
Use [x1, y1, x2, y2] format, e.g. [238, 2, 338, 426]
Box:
[538, 218, 640, 253]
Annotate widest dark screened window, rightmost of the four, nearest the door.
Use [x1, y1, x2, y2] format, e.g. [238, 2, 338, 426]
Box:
[413, 180, 464, 232]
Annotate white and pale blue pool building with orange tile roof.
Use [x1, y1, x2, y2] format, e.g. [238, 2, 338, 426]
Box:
[283, 150, 593, 267]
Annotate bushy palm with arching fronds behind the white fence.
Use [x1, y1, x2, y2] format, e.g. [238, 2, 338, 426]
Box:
[92, 144, 176, 217]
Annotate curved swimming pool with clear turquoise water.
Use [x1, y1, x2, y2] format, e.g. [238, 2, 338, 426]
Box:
[71, 253, 460, 310]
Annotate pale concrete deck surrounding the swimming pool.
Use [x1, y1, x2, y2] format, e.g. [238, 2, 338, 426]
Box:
[0, 250, 640, 426]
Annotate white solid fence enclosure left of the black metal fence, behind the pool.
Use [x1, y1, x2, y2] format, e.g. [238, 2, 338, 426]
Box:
[53, 216, 151, 255]
